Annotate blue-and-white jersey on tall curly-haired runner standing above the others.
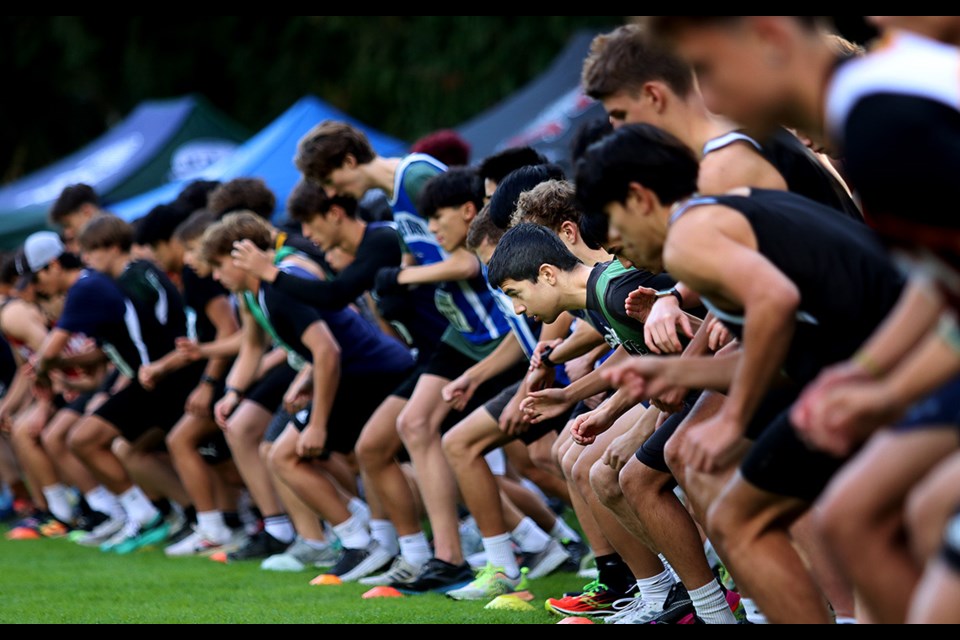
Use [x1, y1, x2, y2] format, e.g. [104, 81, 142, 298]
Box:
[390, 153, 449, 266]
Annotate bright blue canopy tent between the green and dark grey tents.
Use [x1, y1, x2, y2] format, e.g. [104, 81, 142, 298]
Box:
[107, 96, 408, 222]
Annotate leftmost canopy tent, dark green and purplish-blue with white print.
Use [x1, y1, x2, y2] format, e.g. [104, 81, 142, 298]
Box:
[0, 96, 249, 249]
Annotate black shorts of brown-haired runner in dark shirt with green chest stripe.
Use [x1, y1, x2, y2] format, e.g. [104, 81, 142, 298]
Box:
[290, 372, 408, 454]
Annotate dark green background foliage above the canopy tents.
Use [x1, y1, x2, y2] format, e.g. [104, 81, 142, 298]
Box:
[0, 12, 870, 184]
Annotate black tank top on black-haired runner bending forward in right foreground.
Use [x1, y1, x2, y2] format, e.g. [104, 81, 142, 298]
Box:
[671, 189, 905, 384]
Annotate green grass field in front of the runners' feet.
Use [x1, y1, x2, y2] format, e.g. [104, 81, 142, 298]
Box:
[0, 528, 584, 624]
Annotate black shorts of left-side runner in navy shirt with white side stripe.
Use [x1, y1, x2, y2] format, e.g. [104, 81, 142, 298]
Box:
[93, 362, 206, 442]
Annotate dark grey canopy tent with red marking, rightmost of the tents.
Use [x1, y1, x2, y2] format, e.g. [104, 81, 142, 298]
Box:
[457, 31, 606, 172]
